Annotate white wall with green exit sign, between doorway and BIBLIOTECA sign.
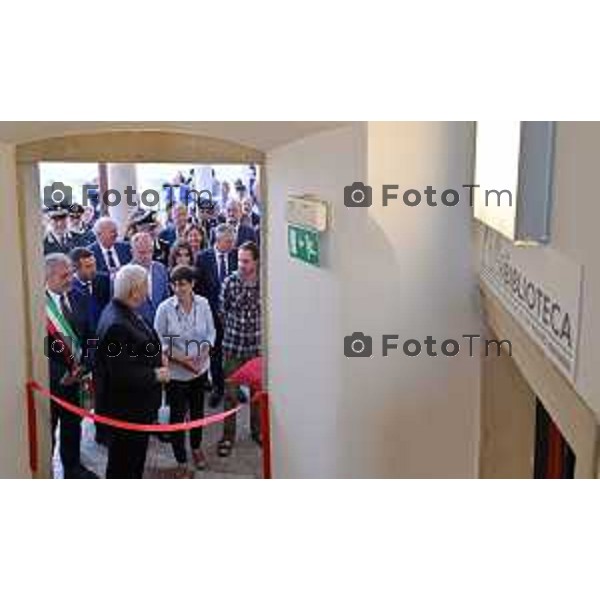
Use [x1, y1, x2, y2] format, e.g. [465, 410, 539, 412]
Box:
[268, 123, 479, 477]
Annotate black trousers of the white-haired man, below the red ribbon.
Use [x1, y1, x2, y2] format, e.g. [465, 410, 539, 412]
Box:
[106, 429, 148, 479]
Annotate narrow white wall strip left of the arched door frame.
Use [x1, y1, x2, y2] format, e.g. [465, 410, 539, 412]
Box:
[0, 143, 29, 478]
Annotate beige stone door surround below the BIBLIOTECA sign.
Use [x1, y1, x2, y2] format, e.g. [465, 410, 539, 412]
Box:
[480, 288, 598, 478]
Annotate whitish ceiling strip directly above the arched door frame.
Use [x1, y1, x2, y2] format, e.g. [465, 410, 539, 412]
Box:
[0, 121, 346, 152]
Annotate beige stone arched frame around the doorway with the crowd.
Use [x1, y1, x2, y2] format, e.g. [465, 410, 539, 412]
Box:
[16, 130, 268, 477]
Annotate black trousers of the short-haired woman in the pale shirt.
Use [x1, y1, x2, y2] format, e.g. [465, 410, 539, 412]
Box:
[167, 373, 208, 464]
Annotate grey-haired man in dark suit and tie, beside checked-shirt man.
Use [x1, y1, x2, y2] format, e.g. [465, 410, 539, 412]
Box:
[196, 223, 237, 408]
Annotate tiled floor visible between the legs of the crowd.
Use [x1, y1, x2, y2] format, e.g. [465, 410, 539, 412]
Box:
[54, 406, 262, 479]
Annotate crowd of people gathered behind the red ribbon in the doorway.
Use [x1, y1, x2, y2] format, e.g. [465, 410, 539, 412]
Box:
[43, 173, 261, 478]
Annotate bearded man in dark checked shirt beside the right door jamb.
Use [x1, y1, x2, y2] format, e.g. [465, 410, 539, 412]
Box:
[218, 242, 261, 456]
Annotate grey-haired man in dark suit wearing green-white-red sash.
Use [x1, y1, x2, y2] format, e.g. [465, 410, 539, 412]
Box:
[45, 253, 96, 479]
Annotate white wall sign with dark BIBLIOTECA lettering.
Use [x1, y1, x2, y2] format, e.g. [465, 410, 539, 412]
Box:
[481, 228, 583, 384]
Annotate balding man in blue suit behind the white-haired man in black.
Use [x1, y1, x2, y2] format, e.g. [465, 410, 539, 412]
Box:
[131, 232, 170, 328]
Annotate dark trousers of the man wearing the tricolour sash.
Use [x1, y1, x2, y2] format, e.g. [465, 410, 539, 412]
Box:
[50, 384, 81, 477]
